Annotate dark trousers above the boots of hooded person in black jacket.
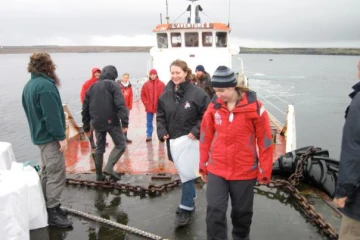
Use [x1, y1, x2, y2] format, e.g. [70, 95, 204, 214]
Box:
[95, 126, 126, 154]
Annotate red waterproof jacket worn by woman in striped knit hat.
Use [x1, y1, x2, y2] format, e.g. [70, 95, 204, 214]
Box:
[199, 92, 273, 182]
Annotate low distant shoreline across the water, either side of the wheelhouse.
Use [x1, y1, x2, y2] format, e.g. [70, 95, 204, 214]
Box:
[0, 46, 360, 56]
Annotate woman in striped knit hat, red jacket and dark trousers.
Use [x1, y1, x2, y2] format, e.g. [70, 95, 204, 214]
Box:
[199, 66, 272, 240]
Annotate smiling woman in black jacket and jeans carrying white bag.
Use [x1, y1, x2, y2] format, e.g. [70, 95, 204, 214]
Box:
[156, 60, 210, 227]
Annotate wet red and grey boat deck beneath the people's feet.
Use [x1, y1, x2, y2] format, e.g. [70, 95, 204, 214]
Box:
[30, 101, 341, 240]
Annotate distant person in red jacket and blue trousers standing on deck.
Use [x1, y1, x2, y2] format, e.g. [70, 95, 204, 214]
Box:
[141, 69, 165, 142]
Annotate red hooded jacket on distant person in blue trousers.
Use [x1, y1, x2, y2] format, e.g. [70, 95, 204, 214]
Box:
[141, 69, 165, 113]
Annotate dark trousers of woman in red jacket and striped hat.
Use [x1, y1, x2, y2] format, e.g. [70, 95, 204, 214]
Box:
[206, 173, 256, 240]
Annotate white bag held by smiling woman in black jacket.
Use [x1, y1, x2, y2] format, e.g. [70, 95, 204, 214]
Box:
[170, 135, 200, 183]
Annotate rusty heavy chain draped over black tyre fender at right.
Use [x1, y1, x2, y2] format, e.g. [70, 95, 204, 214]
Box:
[267, 148, 338, 239]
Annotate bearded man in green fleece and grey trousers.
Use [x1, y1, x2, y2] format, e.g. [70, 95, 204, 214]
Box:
[22, 53, 72, 227]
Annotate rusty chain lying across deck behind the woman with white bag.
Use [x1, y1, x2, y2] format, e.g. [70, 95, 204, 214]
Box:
[66, 178, 181, 196]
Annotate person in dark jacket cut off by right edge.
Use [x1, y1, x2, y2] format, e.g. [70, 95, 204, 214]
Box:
[334, 61, 360, 240]
